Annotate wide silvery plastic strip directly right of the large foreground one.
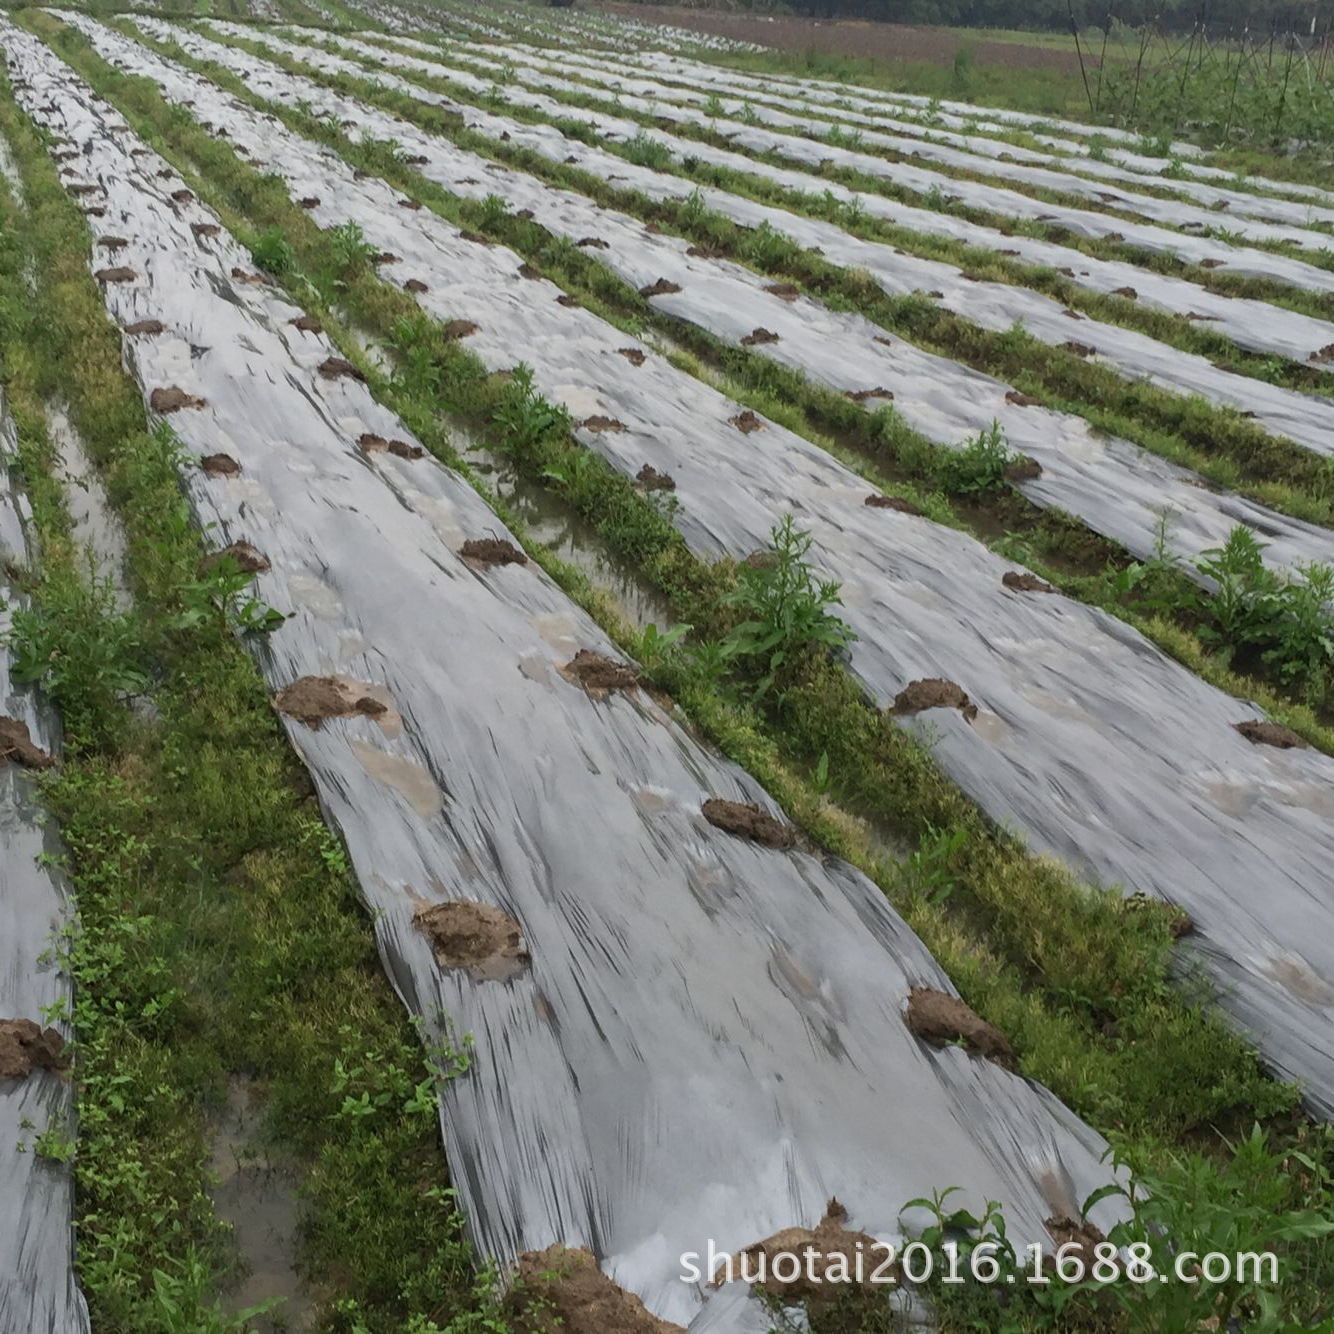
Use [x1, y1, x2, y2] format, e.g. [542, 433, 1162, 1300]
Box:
[39, 23, 1334, 1115]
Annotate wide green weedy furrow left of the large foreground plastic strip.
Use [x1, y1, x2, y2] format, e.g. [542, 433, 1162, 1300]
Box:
[0, 54, 514, 1334]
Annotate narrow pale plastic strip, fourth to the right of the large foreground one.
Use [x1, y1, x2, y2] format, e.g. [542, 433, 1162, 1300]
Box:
[224, 23, 1334, 362]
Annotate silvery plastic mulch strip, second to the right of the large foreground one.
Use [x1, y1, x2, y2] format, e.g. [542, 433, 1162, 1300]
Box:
[101, 23, 1334, 579]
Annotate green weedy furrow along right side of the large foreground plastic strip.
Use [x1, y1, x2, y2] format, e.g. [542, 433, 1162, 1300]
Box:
[29, 17, 1330, 1334]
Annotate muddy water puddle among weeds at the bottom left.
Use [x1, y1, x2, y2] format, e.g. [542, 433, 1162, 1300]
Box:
[209, 1078, 317, 1334]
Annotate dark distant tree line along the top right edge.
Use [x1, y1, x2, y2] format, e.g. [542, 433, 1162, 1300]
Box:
[672, 0, 1334, 33]
